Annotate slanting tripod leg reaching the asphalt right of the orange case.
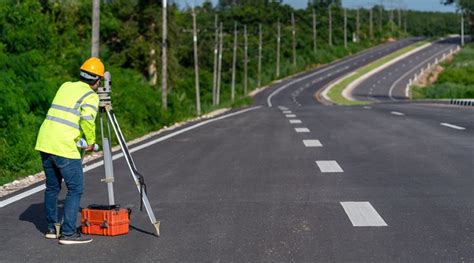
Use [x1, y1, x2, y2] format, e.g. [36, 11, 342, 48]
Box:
[106, 110, 160, 236]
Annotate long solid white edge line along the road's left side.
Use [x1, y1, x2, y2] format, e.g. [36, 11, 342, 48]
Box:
[0, 106, 262, 208]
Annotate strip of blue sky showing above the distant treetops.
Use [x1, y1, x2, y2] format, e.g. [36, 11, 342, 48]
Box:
[190, 0, 456, 12]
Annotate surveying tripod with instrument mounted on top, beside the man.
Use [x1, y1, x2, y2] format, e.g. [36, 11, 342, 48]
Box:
[97, 71, 160, 236]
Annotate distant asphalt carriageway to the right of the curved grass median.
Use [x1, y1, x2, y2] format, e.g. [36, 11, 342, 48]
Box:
[352, 38, 460, 102]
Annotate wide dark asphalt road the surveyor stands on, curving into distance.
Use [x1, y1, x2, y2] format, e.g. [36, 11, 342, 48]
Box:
[0, 39, 474, 262]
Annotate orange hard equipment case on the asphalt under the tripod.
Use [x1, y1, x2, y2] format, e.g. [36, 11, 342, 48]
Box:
[81, 205, 131, 236]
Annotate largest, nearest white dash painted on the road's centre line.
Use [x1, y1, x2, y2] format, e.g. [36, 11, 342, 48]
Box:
[341, 202, 387, 226]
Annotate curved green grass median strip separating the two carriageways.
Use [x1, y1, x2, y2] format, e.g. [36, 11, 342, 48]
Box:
[327, 41, 429, 106]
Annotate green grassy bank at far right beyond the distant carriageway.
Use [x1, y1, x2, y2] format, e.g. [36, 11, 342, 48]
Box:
[412, 43, 474, 99]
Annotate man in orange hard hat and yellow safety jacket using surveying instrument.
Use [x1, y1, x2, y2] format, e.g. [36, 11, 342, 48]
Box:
[35, 57, 104, 245]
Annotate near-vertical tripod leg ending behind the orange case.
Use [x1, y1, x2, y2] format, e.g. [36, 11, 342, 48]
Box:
[99, 109, 115, 205]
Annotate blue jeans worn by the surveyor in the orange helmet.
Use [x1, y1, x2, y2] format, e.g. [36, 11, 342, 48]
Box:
[40, 152, 84, 236]
